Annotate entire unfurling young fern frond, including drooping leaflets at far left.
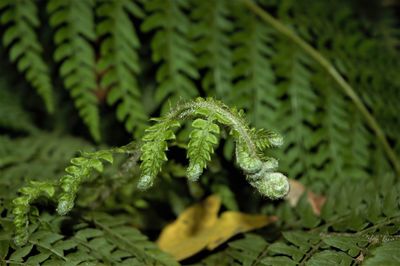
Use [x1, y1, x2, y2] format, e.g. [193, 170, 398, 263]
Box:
[12, 98, 289, 245]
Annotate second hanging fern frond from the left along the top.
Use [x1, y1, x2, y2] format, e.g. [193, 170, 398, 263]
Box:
[47, 0, 100, 141]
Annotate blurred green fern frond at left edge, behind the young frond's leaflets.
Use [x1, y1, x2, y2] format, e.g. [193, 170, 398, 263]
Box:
[0, 131, 91, 203]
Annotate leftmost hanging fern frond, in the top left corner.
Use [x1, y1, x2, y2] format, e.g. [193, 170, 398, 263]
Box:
[0, 0, 54, 113]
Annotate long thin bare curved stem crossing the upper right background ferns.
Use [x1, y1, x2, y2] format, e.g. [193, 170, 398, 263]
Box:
[242, 0, 400, 175]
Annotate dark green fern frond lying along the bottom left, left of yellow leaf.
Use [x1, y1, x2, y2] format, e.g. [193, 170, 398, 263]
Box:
[0, 213, 178, 265]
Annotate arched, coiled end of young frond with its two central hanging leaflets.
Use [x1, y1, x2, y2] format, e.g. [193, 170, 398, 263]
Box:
[138, 98, 289, 199]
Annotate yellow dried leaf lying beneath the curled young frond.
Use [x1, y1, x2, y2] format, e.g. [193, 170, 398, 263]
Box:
[157, 195, 276, 260]
